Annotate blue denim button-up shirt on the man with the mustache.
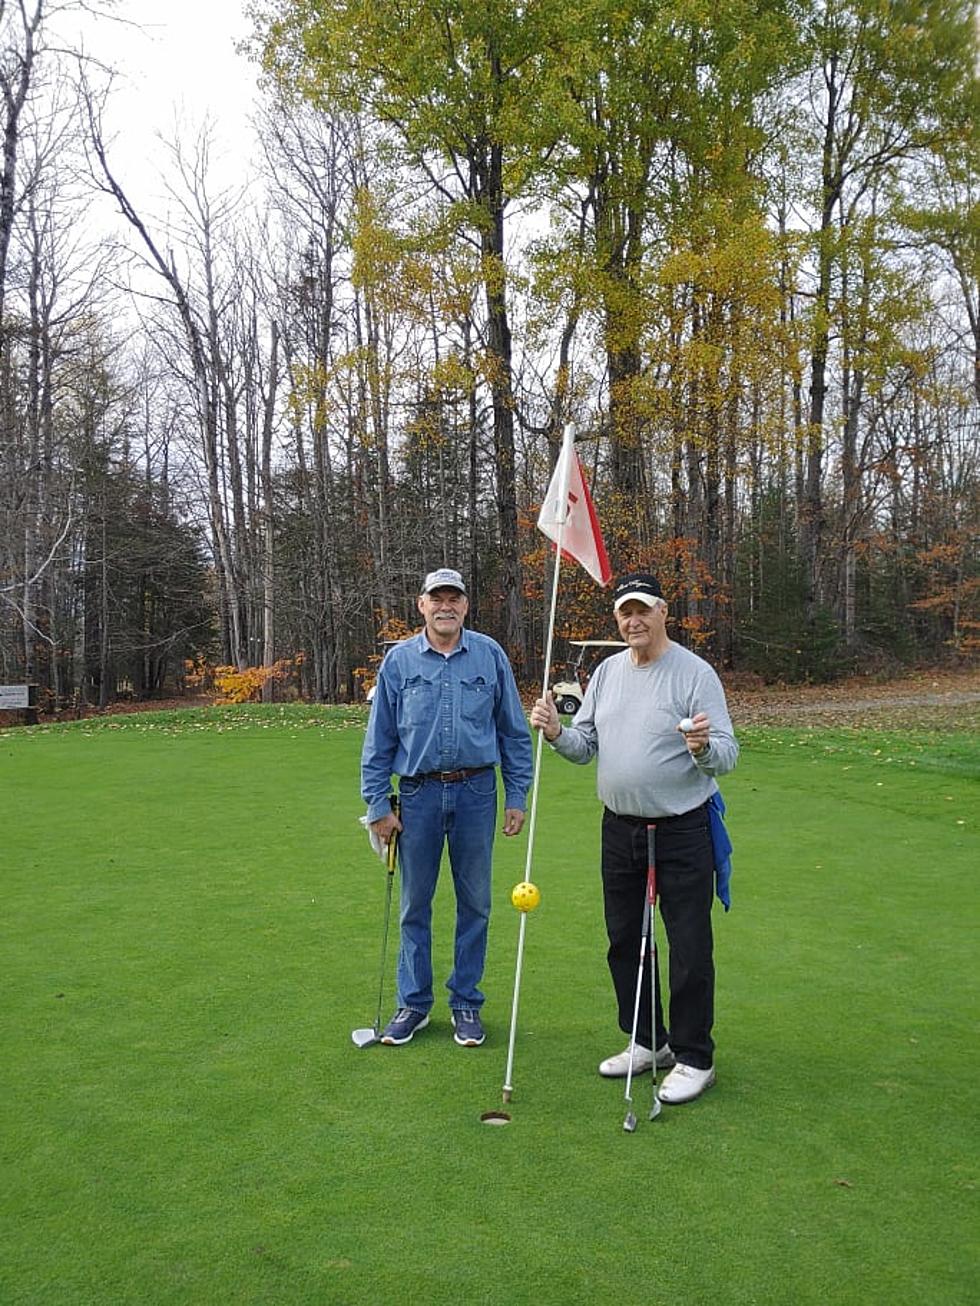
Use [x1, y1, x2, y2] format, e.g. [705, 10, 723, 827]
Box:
[361, 627, 533, 821]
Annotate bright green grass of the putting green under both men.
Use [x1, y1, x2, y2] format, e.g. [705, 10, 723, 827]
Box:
[0, 708, 980, 1306]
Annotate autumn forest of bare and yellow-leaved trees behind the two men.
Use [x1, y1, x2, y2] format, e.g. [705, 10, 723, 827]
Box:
[0, 0, 980, 709]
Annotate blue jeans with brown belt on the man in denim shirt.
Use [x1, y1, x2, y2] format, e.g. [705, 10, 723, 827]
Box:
[397, 768, 497, 1012]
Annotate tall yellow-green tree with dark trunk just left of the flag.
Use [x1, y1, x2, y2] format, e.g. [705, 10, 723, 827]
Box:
[264, 0, 582, 658]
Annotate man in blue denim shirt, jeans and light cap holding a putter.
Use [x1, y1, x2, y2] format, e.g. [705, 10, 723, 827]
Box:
[361, 567, 533, 1047]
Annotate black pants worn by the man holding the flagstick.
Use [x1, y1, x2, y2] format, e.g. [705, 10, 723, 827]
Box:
[602, 806, 715, 1070]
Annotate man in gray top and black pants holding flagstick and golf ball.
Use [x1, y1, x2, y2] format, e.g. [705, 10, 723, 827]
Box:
[531, 572, 738, 1104]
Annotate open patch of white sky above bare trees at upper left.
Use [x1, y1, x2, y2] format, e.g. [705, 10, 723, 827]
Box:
[69, 0, 257, 205]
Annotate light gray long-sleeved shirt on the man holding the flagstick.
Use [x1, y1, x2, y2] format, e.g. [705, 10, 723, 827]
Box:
[551, 643, 738, 818]
